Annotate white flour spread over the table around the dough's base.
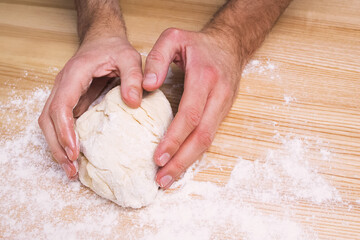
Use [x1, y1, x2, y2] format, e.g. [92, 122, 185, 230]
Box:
[0, 62, 354, 240]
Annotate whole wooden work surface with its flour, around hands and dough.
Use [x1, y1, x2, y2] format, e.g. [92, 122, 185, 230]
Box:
[0, 0, 360, 240]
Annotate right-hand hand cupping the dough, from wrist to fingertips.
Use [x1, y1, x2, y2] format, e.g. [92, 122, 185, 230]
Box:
[143, 29, 243, 188]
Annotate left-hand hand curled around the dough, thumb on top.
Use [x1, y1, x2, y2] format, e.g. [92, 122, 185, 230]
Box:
[39, 37, 143, 178]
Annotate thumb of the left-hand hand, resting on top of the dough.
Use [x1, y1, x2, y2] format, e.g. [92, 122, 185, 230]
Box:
[118, 51, 143, 108]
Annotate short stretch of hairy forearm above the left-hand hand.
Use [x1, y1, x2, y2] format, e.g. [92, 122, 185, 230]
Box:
[75, 0, 126, 42]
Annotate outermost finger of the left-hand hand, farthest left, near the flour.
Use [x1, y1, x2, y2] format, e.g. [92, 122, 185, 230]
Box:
[39, 115, 78, 178]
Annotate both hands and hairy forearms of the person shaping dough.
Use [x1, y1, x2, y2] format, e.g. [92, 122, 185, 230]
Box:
[39, 0, 291, 189]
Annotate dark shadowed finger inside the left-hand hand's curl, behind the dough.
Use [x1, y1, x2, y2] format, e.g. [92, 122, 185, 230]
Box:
[73, 77, 112, 117]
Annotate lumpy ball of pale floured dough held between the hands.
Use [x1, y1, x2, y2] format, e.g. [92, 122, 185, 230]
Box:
[75, 86, 173, 208]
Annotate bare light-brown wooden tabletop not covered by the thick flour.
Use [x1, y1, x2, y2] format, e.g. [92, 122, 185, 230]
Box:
[0, 0, 360, 239]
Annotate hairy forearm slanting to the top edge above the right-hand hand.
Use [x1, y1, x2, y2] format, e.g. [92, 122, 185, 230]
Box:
[203, 0, 291, 64]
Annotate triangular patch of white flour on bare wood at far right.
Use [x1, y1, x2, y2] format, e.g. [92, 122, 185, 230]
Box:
[227, 137, 342, 204]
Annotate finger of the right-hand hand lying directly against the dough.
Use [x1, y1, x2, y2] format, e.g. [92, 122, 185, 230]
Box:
[154, 67, 214, 166]
